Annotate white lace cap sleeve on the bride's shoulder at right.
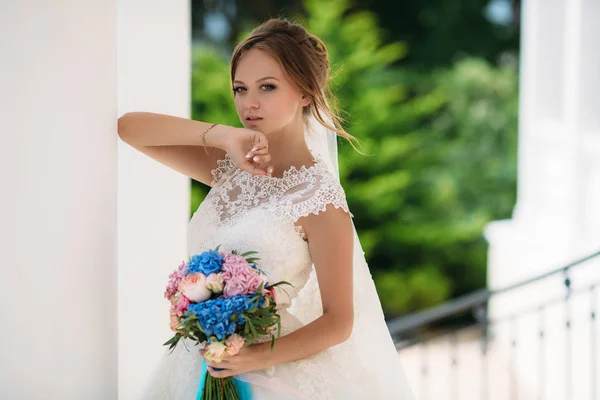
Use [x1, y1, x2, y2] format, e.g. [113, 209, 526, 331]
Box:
[287, 175, 354, 222]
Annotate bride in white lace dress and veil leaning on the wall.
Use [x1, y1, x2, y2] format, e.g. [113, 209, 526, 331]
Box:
[118, 19, 413, 400]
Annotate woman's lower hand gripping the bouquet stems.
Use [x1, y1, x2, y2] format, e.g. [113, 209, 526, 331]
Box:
[200, 342, 271, 378]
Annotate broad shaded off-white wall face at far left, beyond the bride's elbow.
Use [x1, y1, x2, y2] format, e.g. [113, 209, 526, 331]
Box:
[0, 0, 118, 400]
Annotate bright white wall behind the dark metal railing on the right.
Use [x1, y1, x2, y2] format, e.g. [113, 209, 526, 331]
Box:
[486, 0, 600, 399]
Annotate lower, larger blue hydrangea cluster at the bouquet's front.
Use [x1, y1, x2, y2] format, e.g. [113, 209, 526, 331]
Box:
[186, 295, 264, 340]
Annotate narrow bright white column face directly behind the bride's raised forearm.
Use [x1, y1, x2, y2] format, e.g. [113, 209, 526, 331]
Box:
[113, 0, 191, 400]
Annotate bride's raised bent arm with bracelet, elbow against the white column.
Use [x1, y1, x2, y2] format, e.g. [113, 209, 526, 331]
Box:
[118, 112, 271, 185]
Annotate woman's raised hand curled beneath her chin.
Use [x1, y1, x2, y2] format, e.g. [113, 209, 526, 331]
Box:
[224, 128, 273, 175]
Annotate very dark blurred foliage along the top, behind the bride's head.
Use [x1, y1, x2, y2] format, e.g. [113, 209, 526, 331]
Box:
[192, 0, 521, 68]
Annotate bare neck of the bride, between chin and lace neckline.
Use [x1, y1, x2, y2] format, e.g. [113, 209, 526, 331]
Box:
[267, 116, 313, 177]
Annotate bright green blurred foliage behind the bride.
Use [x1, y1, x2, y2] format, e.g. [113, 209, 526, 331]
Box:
[192, 0, 518, 317]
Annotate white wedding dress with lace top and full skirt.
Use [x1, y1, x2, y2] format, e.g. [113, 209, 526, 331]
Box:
[143, 117, 413, 400]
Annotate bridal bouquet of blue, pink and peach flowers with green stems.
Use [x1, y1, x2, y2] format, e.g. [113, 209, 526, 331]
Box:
[164, 246, 289, 400]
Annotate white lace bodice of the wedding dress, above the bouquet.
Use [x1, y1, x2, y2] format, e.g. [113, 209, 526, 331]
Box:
[188, 155, 349, 309]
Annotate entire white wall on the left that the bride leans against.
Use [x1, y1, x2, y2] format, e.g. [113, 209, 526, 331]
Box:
[0, 0, 190, 400]
